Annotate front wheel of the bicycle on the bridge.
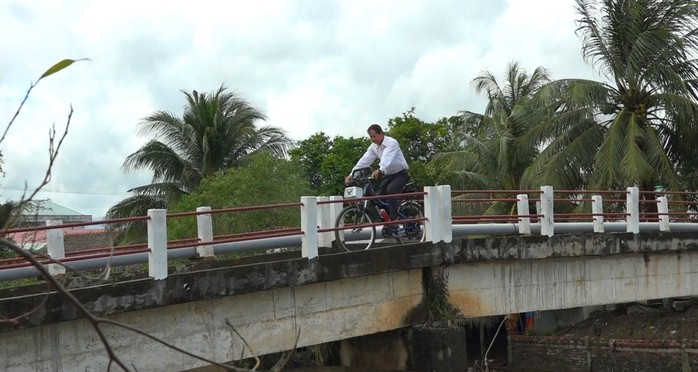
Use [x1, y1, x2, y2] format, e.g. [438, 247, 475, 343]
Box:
[334, 205, 376, 252]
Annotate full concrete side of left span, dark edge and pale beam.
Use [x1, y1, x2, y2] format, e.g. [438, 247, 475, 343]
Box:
[0, 245, 440, 371]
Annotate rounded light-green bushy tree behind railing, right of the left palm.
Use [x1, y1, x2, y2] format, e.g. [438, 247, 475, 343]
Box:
[168, 152, 312, 239]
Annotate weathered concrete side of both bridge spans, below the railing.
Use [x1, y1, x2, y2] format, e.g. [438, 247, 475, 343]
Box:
[0, 233, 698, 371]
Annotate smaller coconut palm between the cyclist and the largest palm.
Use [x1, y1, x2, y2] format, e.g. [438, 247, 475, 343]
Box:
[430, 62, 550, 214]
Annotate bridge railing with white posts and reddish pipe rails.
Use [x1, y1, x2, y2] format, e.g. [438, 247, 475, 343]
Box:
[0, 185, 698, 281]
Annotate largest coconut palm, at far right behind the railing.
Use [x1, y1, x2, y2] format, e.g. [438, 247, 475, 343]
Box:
[524, 0, 698, 190]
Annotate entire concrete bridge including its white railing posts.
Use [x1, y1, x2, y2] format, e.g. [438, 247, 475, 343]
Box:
[0, 187, 698, 371]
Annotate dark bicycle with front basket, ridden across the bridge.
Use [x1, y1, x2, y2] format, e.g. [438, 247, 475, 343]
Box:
[335, 168, 425, 252]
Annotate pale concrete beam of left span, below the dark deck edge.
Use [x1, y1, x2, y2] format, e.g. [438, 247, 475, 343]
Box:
[0, 270, 422, 371]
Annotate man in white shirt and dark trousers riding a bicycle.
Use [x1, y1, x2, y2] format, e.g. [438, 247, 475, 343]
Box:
[345, 124, 410, 221]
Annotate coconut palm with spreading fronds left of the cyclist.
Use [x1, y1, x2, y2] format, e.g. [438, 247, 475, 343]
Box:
[107, 86, 290, 244]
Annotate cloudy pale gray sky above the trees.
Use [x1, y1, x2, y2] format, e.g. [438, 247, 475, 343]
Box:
[0, 0, 598, 219]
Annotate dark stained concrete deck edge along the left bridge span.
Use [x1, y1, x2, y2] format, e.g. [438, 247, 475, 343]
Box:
[0, 244, 444, 331]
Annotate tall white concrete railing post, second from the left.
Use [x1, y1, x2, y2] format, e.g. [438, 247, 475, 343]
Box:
[148, 209, 167, 280]
